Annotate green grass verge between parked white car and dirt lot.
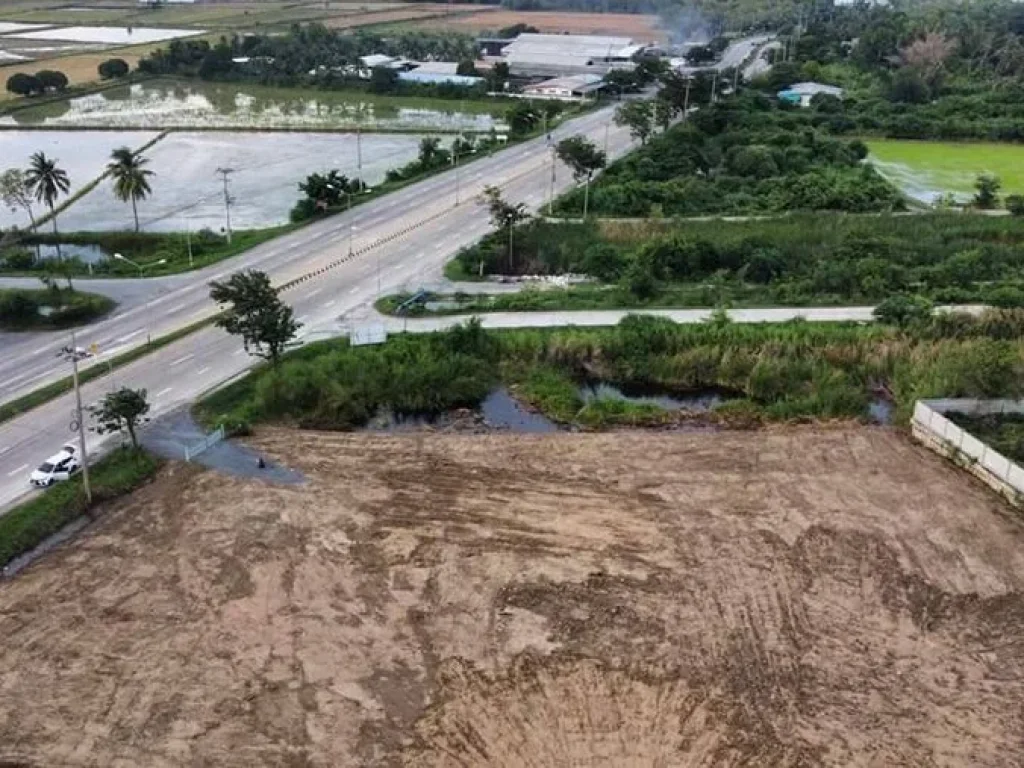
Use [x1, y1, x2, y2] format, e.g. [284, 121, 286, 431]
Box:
[0, 449, 161, 566]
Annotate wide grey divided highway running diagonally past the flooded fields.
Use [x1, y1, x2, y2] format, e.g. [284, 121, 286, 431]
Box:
[0, 102, 632, 508]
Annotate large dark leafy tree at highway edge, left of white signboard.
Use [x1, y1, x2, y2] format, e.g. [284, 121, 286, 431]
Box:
[210, 269, 302, 366]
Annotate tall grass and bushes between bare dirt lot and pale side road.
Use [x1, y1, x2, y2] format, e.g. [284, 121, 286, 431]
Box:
[200, 310, 1024, 429]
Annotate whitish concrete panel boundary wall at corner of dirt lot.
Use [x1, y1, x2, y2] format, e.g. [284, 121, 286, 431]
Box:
[910, 399, 1024, 507]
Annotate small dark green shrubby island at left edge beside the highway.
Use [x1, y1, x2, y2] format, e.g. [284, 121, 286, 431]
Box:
[0, 283, 115, 331]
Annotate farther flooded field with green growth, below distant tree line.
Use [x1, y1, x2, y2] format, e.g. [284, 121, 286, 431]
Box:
[0, 79, 505, 131]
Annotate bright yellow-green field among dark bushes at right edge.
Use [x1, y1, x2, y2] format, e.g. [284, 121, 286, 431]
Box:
[867, 139, 1024, 201]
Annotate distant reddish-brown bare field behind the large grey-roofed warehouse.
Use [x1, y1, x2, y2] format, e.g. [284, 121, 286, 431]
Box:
[422, 10, 666, 41]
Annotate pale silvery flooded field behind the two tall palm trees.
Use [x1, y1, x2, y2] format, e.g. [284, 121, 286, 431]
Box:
[0, 131, 423, 231]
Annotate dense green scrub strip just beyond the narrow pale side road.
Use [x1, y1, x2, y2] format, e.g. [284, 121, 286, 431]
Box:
[442, 212, 1024, 311]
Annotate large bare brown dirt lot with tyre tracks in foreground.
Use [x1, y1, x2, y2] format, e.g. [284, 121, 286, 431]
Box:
[0, 428, 1024, 768]
